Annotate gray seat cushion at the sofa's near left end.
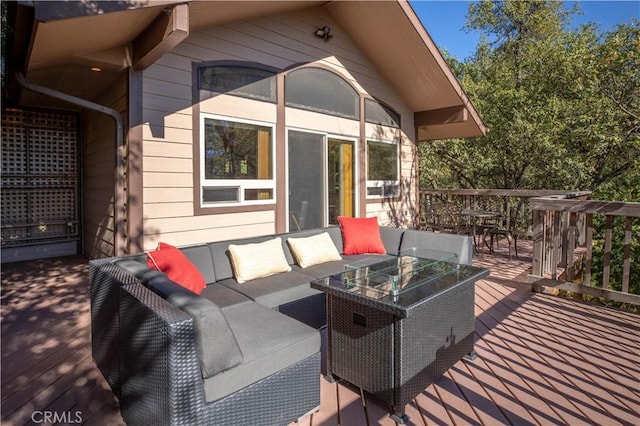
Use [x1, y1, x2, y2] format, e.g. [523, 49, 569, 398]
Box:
[204, 303, 320, 402]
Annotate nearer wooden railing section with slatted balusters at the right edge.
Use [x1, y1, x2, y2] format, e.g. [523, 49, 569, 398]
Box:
[529, 197, 640, 305]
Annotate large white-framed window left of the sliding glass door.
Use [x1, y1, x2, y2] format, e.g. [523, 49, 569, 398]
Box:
[201, 115, 275, 207]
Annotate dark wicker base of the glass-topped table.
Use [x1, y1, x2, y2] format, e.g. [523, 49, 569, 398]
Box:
[327, 272, 475, 423]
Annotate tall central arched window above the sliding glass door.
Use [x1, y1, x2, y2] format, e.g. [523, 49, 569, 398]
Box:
[285, 68, 360, 120]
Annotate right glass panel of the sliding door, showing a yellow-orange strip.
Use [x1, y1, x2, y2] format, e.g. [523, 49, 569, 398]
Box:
[327, 139, 355, 225]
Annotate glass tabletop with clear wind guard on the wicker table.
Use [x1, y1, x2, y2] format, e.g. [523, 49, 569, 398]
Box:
[311, 248, 488, 317]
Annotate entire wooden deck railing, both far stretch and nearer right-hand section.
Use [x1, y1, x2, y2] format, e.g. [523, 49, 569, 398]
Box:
[419, 189, 640, 305]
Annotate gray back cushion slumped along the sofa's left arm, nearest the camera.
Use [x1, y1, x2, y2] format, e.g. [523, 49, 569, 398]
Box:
[147, 276, 243, 379]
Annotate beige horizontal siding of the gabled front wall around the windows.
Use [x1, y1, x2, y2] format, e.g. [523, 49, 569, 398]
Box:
[142, 8, 417, 250]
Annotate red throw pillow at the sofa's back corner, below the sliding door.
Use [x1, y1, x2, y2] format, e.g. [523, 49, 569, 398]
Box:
[338, 216, 387, 254]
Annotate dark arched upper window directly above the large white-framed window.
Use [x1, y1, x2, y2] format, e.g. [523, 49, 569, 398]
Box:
[198, 62, 276, 102]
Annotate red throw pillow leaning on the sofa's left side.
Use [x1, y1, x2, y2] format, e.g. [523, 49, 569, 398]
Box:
[147, 243, 206, 294]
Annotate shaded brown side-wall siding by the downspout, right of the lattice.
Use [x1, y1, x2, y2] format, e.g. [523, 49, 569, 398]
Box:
[82, 76, 127, 258]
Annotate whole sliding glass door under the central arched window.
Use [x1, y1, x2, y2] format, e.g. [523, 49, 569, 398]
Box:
[288, 130, 356, 231]
